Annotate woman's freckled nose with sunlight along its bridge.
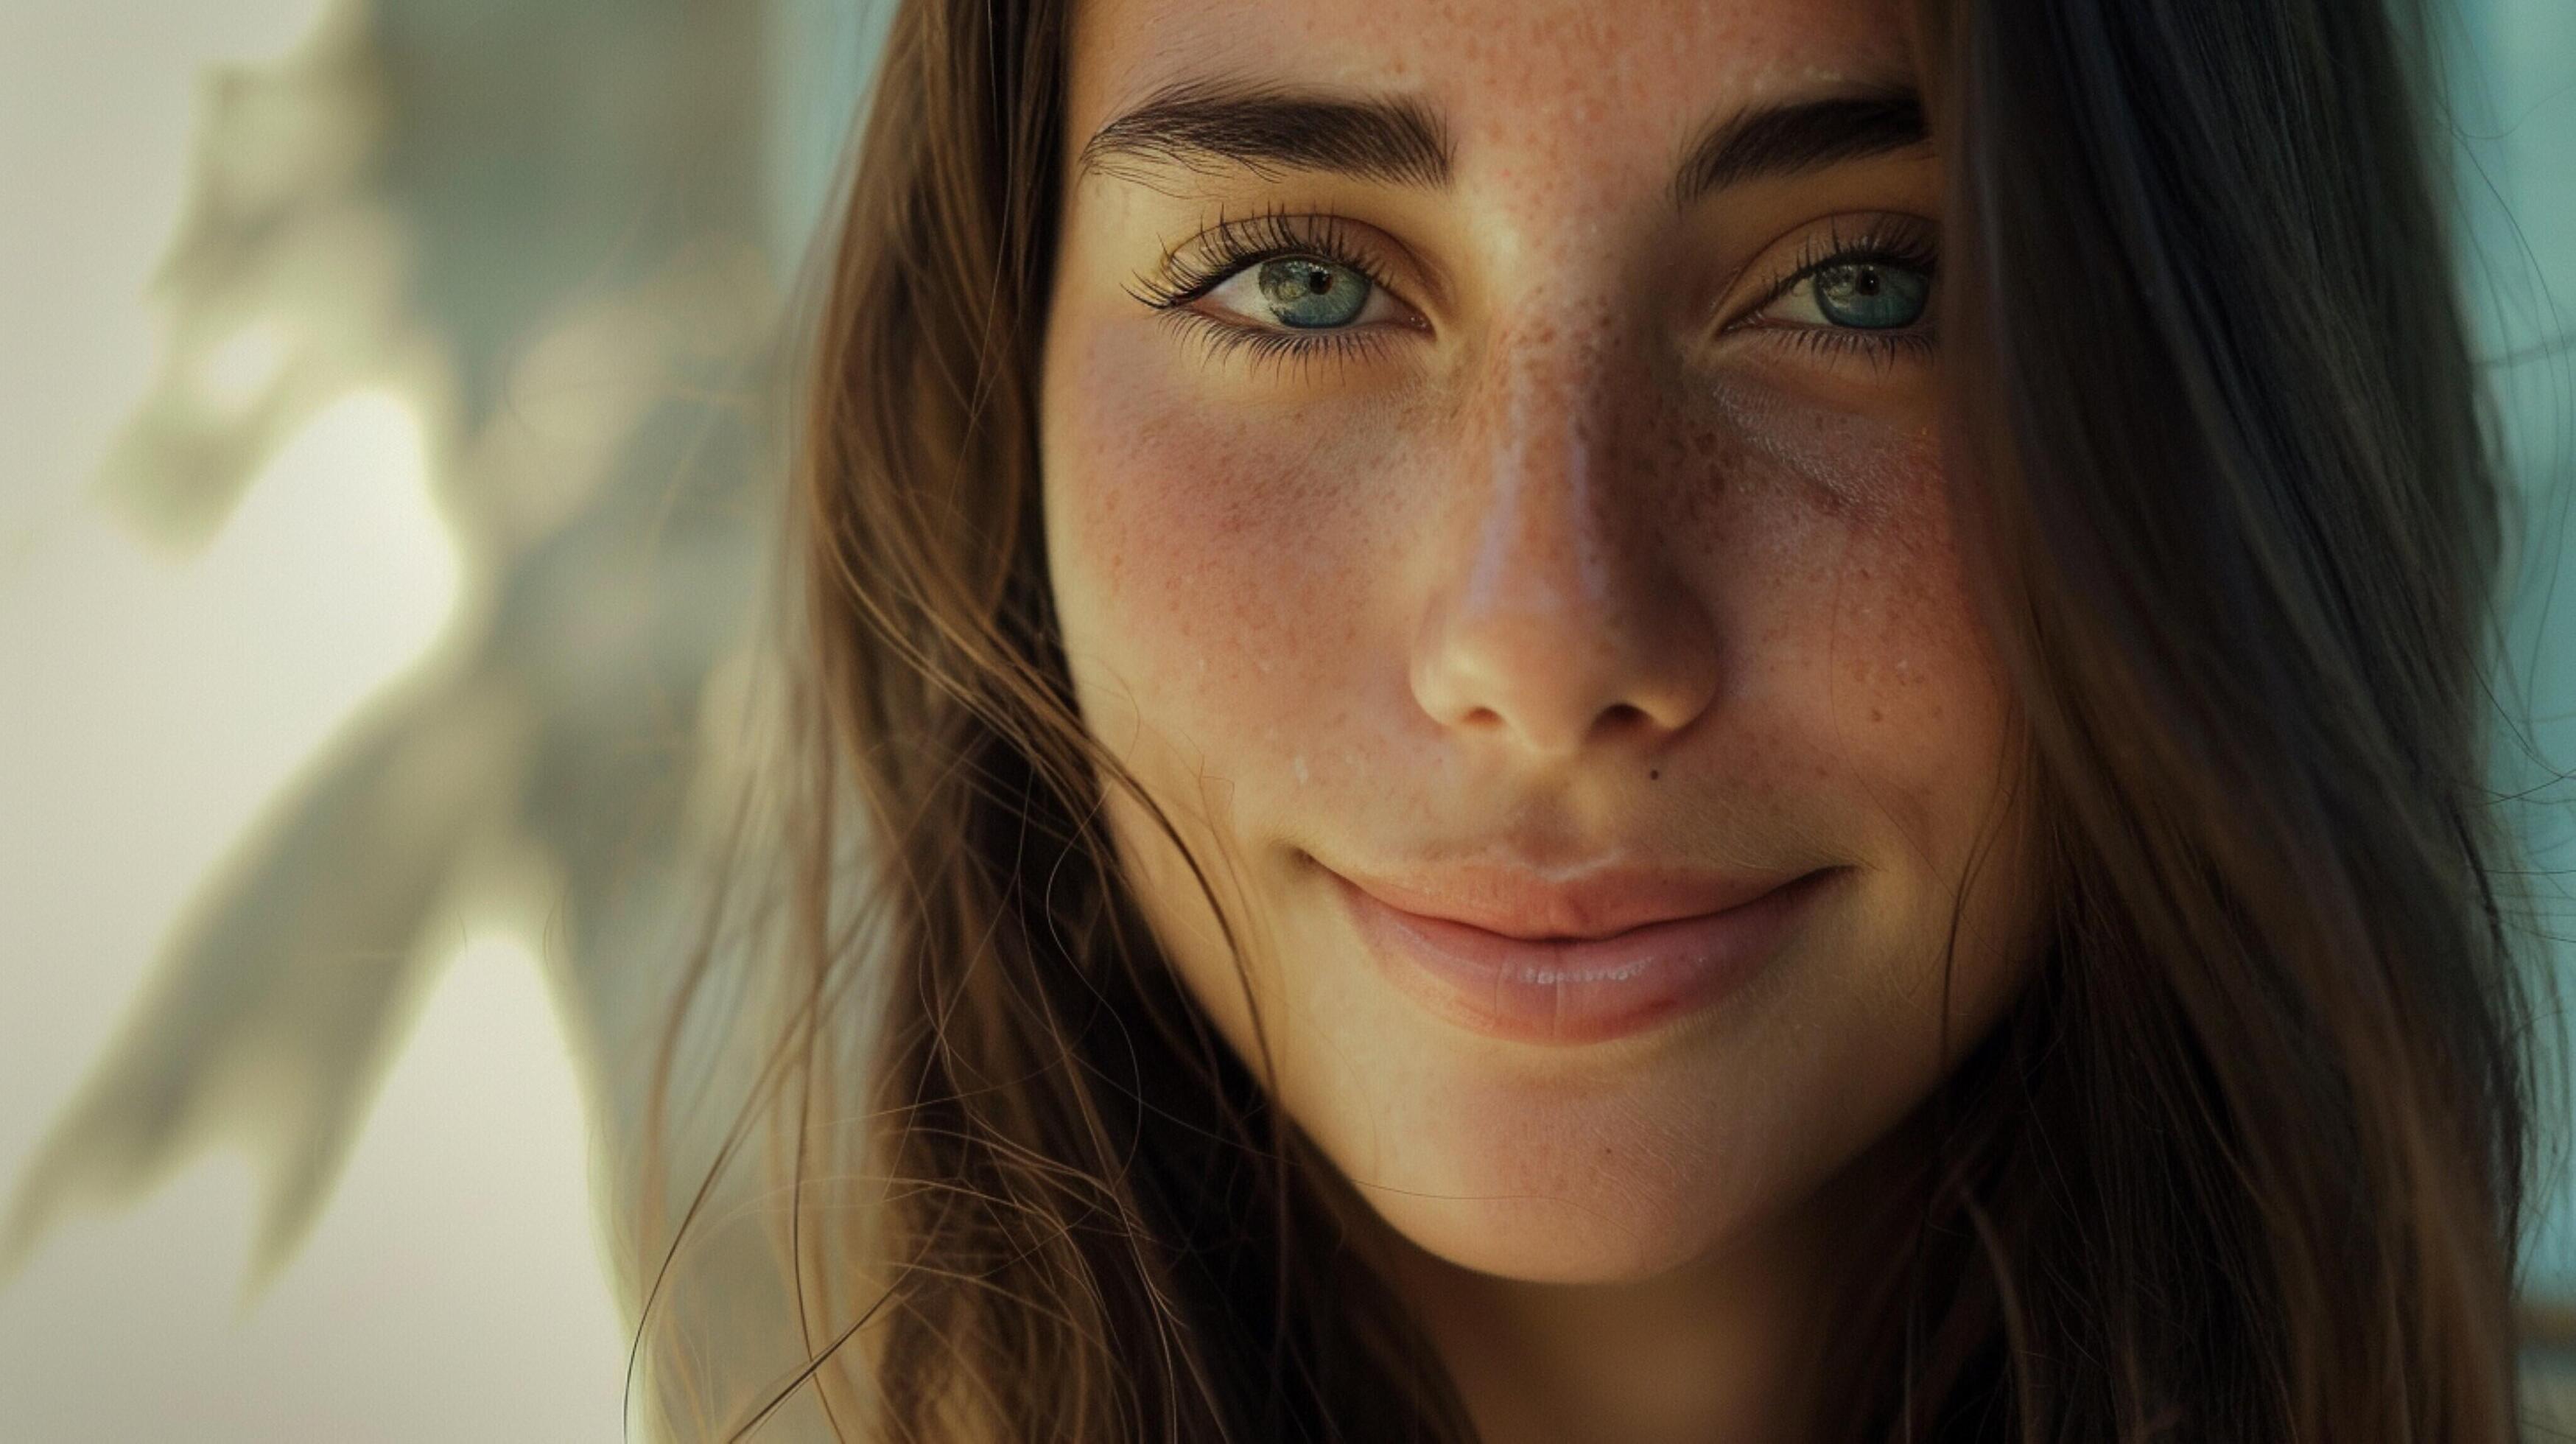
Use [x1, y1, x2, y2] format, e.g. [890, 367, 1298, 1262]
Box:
[1411, 326, 1721, 761]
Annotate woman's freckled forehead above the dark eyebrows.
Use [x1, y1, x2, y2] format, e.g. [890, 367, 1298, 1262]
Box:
[1067, 0, 1917, 170]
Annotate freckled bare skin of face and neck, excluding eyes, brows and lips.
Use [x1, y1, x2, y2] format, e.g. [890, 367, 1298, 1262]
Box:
[1041, 0, 2035, 1439]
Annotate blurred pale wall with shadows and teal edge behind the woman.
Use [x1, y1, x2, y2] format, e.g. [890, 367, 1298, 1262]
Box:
[0, 0, 2576, 1442]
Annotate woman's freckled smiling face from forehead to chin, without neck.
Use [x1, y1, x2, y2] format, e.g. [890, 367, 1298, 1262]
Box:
[1043, 0, 2035, 1282]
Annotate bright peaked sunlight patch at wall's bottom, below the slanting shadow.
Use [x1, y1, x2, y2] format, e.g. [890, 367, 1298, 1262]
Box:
[0, 931, 626, 1444]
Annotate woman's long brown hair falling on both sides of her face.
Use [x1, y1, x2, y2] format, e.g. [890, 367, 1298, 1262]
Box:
[642, 0, 2533, 1444]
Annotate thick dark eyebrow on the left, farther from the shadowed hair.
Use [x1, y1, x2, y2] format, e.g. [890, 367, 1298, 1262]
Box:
[1074, 80, 1450, 189]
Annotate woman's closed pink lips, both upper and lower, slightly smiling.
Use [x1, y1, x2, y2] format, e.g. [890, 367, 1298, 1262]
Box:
[1327, 869, 1842, 1045]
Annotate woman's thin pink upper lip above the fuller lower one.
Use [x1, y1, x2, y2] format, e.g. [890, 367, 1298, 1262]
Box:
[1332, 864, 1814, 942]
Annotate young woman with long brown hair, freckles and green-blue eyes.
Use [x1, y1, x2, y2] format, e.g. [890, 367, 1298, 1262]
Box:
[634, 0, 2527, 1444]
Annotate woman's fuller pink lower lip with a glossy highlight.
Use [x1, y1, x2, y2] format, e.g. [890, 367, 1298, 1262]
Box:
[1334, 869, 1834, 1045]
